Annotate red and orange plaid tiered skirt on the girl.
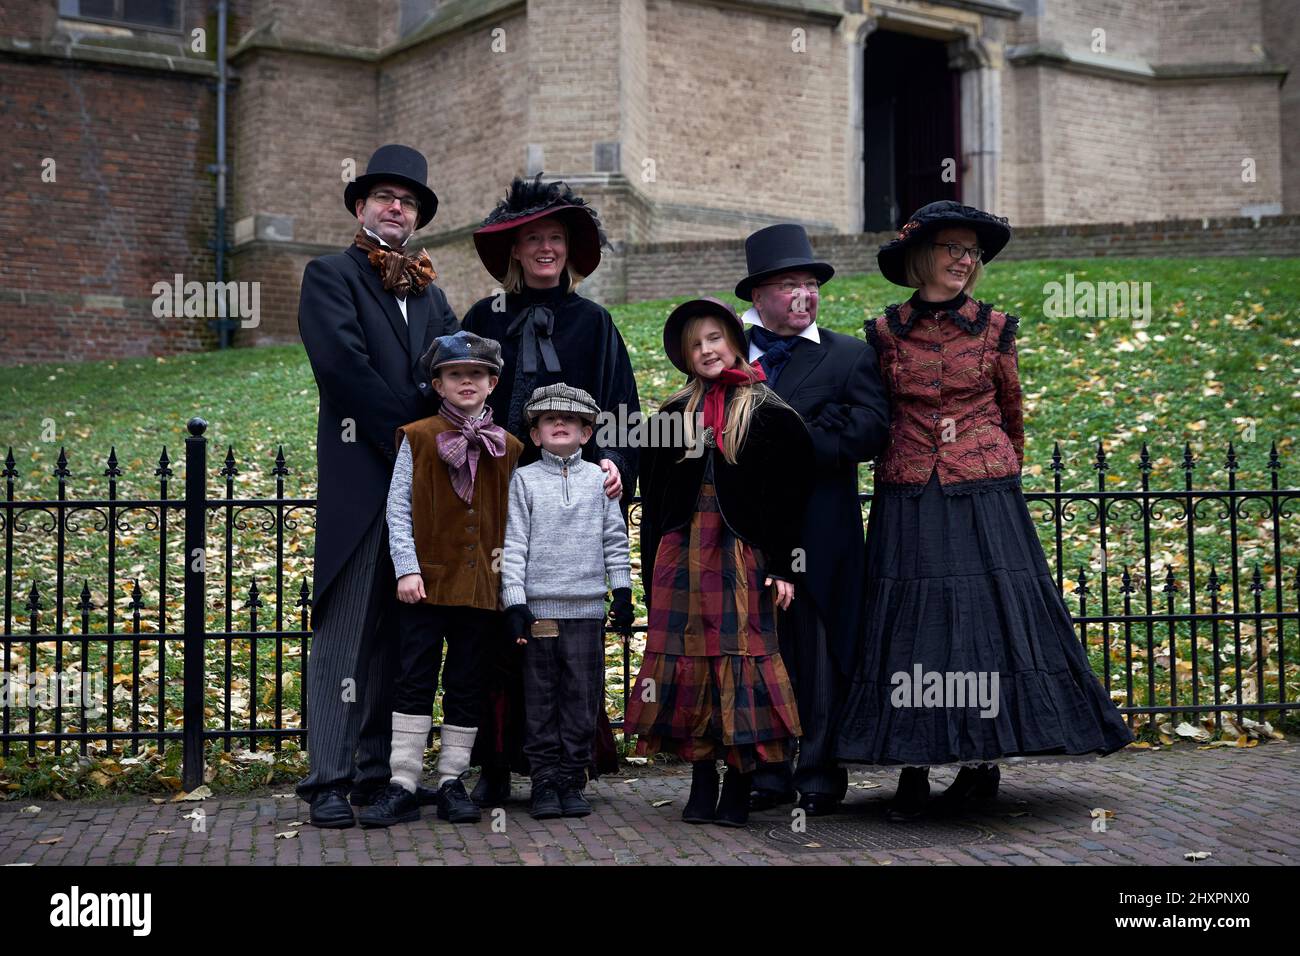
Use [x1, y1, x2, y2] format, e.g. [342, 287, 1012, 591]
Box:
[627, 483, 801, 773]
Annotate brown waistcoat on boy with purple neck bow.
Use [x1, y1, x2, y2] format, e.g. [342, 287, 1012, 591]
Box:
[397, 415, 524, 611]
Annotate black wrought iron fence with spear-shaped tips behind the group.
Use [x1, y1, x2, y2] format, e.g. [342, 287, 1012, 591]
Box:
[0, 419, 1300, 788]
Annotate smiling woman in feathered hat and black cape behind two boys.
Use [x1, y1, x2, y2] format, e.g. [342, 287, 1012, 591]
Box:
[462, 173, 641, 806]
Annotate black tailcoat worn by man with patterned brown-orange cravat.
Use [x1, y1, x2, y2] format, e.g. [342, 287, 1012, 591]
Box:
[298, 246, 459, 606]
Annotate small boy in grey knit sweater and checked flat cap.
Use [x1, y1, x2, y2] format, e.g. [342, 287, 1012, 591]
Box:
[501, 382, 632, 819]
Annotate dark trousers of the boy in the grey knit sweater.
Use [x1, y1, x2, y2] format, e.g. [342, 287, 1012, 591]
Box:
[524, 618, 605, 790]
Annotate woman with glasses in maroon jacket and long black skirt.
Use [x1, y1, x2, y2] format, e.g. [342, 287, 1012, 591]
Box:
[836, 200, 1132, 819]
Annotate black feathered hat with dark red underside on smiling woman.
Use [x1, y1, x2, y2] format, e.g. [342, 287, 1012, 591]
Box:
[475, 173, 607, 280]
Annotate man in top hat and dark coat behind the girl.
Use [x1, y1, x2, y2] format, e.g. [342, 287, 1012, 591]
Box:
[736, 222, 889, 816]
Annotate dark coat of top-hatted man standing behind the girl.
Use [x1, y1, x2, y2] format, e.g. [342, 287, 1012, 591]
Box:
[746, 328, 889, 675]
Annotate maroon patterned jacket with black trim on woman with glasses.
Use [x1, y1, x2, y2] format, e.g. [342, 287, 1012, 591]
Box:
[866, 294, 1024, 494]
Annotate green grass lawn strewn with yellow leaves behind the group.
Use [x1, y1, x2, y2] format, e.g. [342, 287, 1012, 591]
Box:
[0, 259, 1300, 793]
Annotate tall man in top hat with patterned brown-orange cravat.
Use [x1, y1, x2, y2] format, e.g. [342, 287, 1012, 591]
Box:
[298, 144, 459, 827]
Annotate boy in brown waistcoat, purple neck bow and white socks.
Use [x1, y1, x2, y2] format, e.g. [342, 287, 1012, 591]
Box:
[358, 332, 524, 827]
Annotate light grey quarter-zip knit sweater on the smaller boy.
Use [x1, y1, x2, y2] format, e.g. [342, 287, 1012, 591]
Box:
[501, 449, 632, 618]
